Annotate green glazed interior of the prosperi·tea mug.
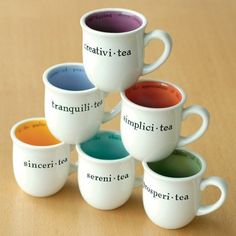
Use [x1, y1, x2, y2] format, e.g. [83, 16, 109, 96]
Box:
[147, 150, 202, 178]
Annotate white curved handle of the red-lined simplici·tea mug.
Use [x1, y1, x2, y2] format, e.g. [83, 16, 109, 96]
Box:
[177, 105, 210, 147]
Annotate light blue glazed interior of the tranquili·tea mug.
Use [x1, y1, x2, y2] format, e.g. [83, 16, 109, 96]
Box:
[47, 64, 95, 91]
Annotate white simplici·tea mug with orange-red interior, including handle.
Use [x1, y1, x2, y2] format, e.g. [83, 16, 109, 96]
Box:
[120, 80, 209, 161]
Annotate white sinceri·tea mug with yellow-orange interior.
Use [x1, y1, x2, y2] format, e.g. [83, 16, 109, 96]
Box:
[10, 117, 74, 197]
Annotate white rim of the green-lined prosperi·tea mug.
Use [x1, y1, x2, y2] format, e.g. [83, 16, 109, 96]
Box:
[142, 148, 206, 182]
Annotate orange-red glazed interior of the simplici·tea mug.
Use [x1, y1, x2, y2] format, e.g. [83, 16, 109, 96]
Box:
[125, 81, 182, 108]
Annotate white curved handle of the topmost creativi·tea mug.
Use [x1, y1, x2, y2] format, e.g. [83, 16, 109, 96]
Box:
[142, 30, 172, 75]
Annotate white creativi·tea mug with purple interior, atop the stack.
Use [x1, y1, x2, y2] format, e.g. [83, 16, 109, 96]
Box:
[80, 8, 172, 92]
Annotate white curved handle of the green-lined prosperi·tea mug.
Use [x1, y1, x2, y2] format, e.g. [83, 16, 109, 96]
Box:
[197, 176, 228, 216]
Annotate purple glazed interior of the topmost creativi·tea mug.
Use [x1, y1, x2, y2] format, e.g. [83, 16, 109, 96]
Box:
[85, 11, 143, 33]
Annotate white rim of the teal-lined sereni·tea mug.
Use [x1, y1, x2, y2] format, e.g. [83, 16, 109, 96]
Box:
[76, 129, 132, 164]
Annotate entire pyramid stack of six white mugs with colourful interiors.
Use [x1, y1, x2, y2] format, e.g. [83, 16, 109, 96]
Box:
[11, 8, 227, 229]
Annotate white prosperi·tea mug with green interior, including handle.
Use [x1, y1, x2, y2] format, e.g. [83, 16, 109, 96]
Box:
[143, 149, 227, 229]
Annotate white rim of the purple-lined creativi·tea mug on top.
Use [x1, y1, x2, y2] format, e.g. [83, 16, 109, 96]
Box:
[80, 7, 147, 37]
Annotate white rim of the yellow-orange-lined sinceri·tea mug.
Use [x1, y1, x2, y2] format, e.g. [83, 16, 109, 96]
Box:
[10, 117, 65, 150]
